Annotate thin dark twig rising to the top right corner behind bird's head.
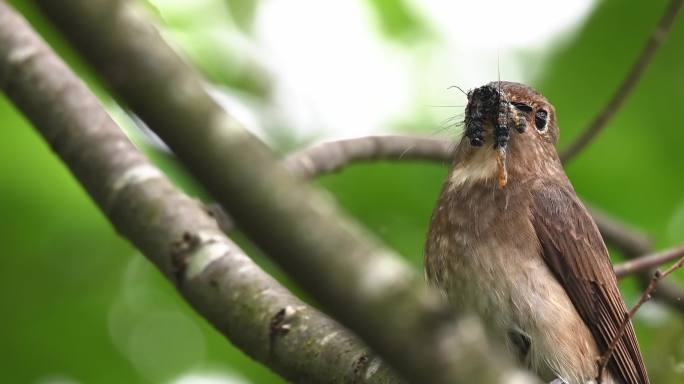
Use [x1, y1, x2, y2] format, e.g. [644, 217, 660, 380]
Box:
[561, 0, 684, 163]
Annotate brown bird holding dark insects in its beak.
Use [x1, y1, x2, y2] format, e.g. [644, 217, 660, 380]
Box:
[425, 82, 649, 384]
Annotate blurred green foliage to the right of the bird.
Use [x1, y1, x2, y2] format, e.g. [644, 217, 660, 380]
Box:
[539, 0, 684, 384]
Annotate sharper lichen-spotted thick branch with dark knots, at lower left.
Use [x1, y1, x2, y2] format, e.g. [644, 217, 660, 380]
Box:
[0, 1, 399, 384]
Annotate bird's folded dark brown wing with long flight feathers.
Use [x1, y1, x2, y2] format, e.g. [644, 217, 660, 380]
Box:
[531, 185, 649, 384]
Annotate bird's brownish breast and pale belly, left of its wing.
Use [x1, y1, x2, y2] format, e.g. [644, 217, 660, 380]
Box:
[425, 176, 597, 378]
